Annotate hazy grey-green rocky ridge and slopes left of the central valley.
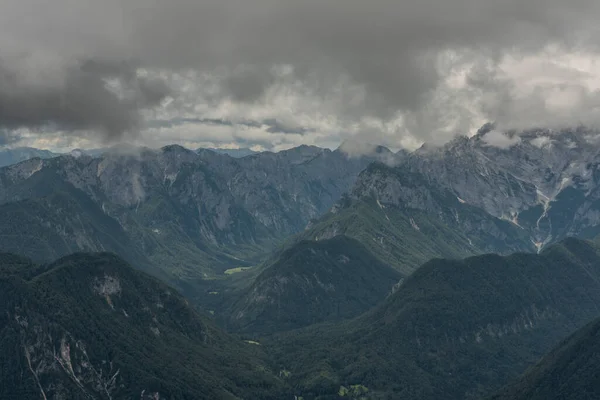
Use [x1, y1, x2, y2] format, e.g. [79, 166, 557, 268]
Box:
[0, 146, 400, 279]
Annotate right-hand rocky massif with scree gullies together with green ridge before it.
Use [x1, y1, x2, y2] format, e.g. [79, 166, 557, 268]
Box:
[286, 126, 600, 274]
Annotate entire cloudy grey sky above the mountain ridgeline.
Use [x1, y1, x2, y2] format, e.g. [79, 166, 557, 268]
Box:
[0, 0, 600, 150]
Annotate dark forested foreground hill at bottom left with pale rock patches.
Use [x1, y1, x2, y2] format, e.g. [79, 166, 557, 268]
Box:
[0, 253, 278, 400]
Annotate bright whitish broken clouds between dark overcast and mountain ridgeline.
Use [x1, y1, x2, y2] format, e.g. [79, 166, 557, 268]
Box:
[9, 49, 600, 150]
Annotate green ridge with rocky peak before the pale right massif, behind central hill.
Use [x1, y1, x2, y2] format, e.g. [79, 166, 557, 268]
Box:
[300, 163, 535, 274]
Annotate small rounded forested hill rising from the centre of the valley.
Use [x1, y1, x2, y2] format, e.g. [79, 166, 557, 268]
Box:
[227, 236, 401, 333]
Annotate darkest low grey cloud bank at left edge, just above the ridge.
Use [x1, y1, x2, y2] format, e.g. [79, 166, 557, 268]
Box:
[0, 57, 168, 139]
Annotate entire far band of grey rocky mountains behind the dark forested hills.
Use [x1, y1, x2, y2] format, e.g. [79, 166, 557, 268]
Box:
[5, 127, 600, 281]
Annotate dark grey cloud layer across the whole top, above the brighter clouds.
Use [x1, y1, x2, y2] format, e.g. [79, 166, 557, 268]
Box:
[0, 0, 600, 143]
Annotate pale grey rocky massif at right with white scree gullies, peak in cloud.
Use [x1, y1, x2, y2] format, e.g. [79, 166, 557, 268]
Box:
[402, 126, 600, 249]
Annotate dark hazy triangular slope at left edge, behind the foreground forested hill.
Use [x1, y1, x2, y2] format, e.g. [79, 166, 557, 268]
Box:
[0, 165, 149, 266]
